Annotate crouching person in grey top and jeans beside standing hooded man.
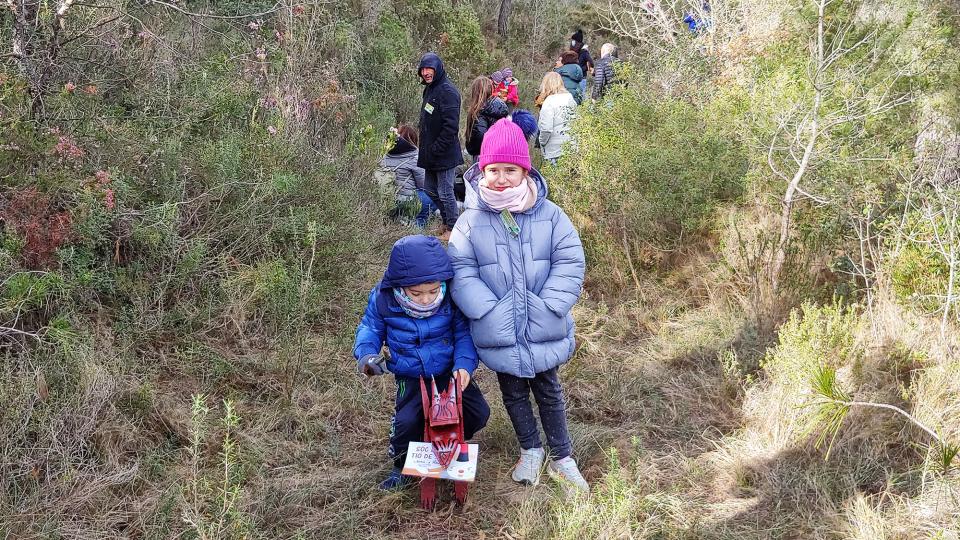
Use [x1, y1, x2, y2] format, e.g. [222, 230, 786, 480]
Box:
[380, 124, 437, 229]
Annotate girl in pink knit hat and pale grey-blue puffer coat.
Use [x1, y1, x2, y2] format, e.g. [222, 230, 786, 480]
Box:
[447, 118, 590, 491]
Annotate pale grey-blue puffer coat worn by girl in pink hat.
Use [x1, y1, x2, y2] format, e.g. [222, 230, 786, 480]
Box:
[447, 164, 586, 377]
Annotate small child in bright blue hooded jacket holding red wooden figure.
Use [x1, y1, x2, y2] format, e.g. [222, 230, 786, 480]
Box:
[353, 235, 490, 490]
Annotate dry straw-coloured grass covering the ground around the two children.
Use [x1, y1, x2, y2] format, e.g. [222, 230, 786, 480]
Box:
[0, 225, 960, 539]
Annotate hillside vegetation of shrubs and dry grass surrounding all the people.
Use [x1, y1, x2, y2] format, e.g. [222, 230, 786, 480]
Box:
[0, 0, 960, 540]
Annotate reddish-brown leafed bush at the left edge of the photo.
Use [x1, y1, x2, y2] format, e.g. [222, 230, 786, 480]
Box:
[0, 187, 73, 270]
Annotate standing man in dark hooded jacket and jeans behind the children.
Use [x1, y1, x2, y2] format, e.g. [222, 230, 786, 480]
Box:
[417, 52, 463, 241]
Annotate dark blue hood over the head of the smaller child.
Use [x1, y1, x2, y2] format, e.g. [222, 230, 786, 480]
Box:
[380, 234, 453, 289]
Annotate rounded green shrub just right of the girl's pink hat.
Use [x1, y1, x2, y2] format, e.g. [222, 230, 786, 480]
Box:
[546, 73, 746, 292]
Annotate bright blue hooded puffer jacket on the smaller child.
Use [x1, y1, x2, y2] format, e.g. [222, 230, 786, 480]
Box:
[353, 235, 478, 377]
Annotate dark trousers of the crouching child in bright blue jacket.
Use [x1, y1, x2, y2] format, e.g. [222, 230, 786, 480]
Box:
[388, 373, 490, 469]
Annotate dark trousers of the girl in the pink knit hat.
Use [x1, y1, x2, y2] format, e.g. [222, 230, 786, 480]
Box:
[497, 368, 573, 459]
